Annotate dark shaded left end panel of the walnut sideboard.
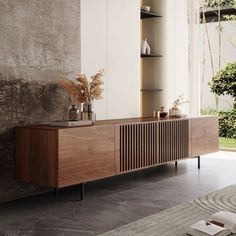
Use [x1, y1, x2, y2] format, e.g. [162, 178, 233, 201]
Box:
[15, 128, 58, 187]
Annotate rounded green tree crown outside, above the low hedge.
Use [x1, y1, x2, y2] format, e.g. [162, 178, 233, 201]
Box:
[209, 62, 236, 109]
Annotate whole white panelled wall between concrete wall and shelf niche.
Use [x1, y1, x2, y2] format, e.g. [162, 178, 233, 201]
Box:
[81, 0, 140, 119]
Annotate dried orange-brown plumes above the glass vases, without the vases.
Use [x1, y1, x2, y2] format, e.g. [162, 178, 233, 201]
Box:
[60, 70, 104, 104]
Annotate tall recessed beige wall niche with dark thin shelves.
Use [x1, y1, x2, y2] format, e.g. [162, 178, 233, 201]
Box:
[140, 0, 164, 117]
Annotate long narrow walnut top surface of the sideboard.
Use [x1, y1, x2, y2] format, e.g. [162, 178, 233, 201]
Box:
[16, 116, 216, 130]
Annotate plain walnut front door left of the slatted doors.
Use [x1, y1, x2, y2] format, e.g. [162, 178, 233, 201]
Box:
[58, 125, 115, 187]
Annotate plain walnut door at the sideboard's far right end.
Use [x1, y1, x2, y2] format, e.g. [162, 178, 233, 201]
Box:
[190, 117, 219, 157]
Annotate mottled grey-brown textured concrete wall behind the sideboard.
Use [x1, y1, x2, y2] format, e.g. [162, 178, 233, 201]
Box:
[0, 0, 80, 202]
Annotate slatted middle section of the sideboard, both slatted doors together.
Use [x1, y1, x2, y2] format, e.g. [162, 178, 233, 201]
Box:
[120, 120, 189, 172]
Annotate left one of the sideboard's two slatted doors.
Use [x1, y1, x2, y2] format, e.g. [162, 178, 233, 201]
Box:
[120, 122, 159, 172]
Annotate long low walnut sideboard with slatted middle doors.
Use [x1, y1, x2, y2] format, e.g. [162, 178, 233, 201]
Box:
[16, 116, 218, 197]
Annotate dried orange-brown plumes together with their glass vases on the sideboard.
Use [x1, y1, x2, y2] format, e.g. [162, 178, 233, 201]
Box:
[60, 70, 104, 123]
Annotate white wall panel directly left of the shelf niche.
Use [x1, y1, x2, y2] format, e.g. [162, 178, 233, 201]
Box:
[108, 0, 140, 118]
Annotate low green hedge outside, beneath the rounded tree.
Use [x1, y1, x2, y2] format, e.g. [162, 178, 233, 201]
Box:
[219, 109, 236, 138]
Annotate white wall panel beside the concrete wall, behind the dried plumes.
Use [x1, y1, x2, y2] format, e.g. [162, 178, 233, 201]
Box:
[81, 0, 108, 119]
